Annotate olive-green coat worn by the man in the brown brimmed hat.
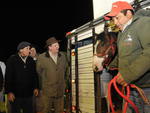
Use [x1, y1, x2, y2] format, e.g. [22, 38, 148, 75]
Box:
[36, 52, 67, 97]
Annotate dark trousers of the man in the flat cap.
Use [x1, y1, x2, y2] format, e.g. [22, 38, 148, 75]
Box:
[10, 97, 33, 113]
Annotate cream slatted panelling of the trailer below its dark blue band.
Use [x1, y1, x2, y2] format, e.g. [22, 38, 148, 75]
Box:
[71, 41, 95, 113]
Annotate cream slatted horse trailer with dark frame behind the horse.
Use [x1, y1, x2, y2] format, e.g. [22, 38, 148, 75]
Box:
[66, 0, 150, 113]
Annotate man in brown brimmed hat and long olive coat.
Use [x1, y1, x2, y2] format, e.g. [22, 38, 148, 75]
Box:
[37, 37, 67, 113]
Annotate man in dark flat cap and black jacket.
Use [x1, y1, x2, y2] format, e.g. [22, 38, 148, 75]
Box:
[5, 41, 39, 113]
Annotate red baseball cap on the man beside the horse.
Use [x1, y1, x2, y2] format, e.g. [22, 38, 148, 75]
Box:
[104, 1, 133, 20]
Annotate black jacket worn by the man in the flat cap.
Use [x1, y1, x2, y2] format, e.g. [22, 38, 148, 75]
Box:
[5, 54, 39, 97]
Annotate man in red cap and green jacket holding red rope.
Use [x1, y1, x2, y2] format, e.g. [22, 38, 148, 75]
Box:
[104, 1, 150, 113]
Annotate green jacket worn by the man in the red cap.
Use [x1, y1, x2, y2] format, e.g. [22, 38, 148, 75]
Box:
[110, 17, 150, 87]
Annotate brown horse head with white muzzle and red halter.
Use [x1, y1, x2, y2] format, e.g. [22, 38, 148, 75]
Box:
[93, 32, 117, 72]
